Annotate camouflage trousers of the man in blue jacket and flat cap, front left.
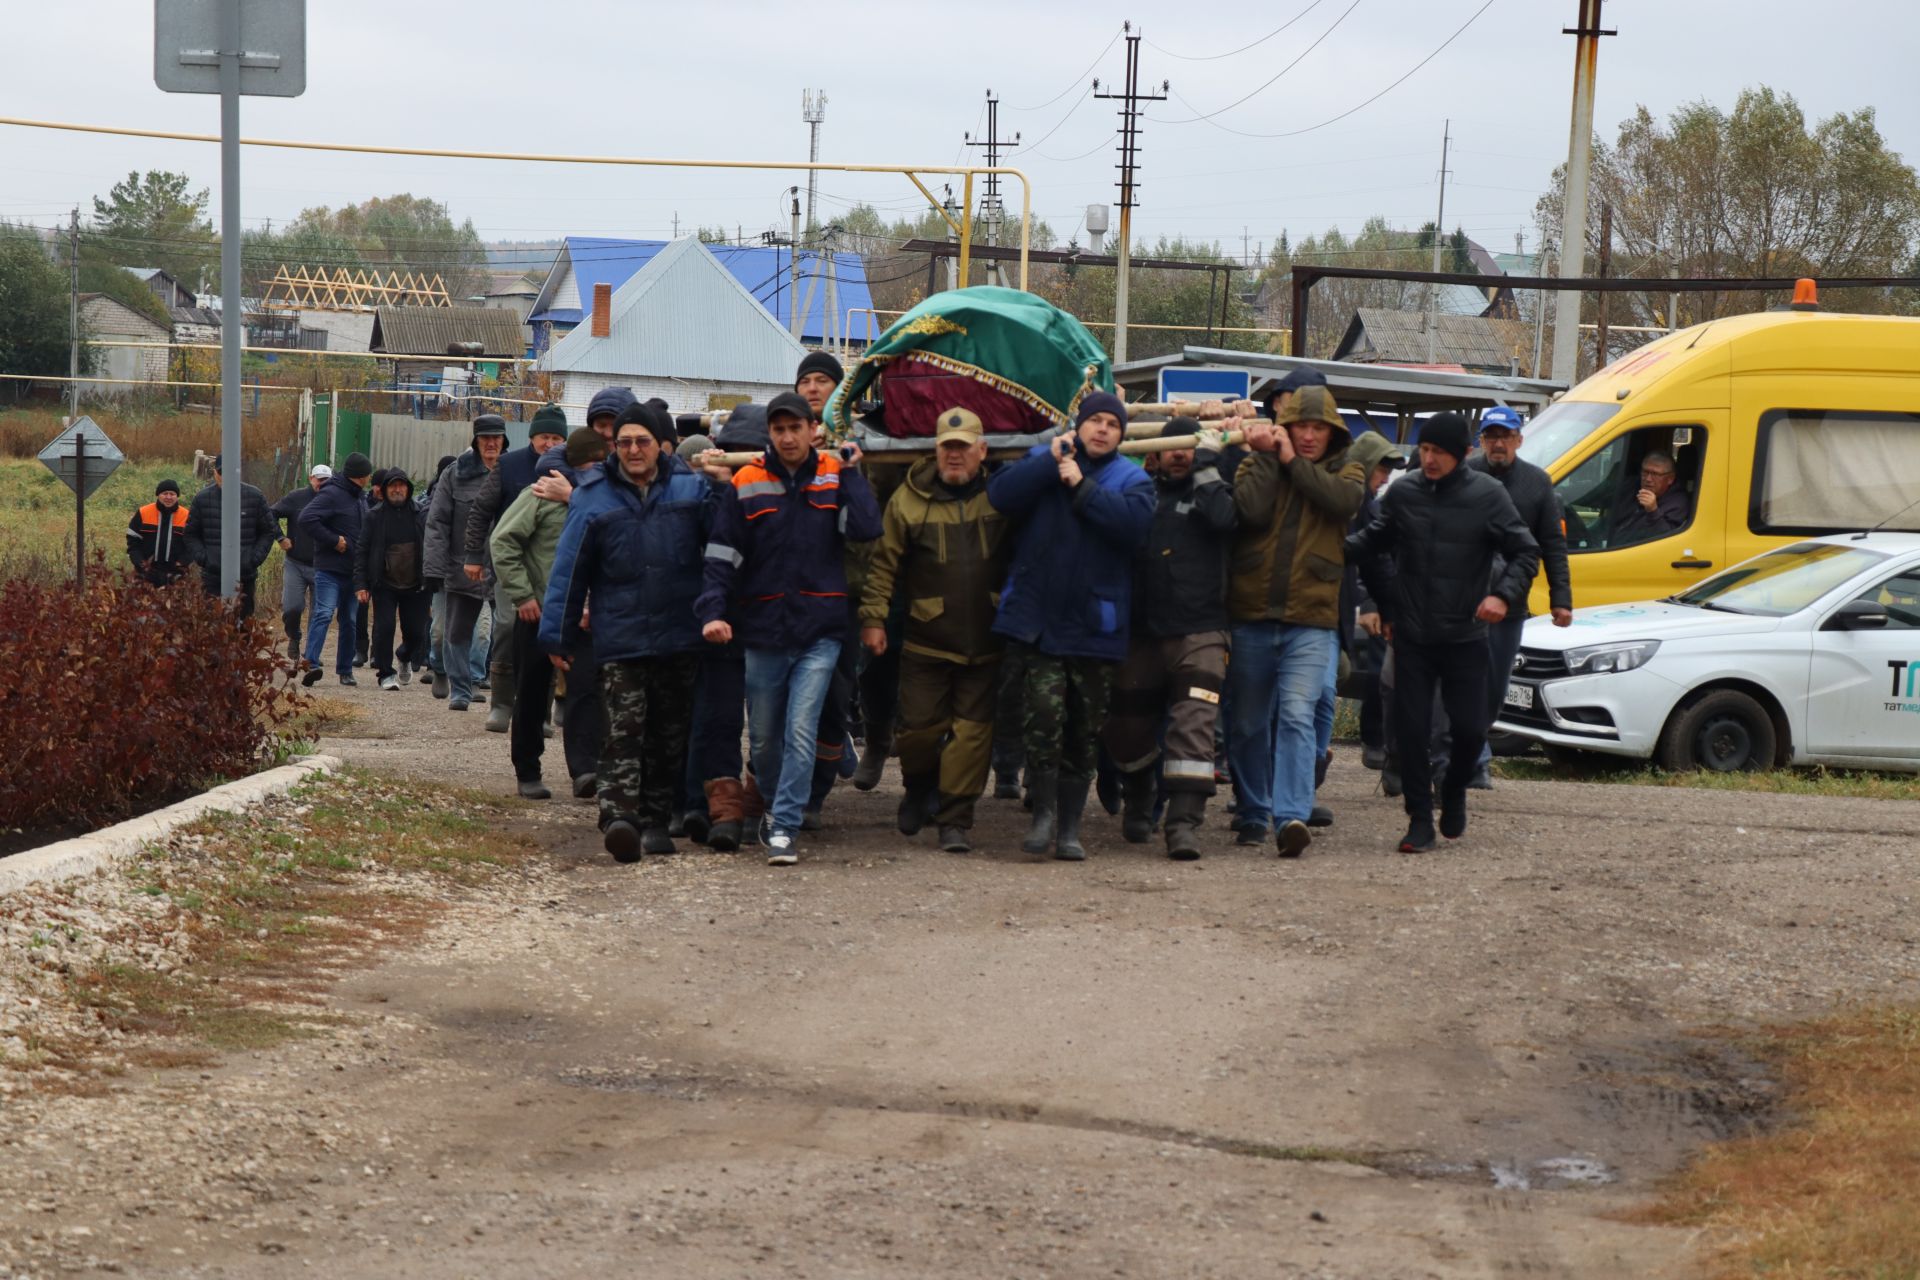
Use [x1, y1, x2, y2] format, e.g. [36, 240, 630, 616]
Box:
[599, 652, 699, 831]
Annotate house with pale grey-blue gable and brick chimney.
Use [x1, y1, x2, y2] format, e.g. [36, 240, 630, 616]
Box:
[536, 236, 806, 426]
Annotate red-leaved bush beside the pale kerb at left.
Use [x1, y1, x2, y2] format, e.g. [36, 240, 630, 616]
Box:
[0, 555, 300, 833]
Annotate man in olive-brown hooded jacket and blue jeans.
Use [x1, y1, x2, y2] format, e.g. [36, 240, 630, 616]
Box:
[1227, 386, 1367, 858]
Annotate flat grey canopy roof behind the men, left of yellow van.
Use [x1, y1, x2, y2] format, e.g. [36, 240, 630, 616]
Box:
[1114, 347, 1567, 439]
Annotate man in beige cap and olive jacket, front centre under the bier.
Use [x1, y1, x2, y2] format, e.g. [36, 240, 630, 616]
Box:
[860, 409, 1010, 854]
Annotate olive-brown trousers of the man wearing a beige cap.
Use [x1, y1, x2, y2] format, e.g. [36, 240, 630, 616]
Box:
[893, 651, 1000, 827]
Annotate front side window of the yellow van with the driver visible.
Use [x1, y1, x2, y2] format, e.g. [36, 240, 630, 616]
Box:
[1553, 426, 1707, 555]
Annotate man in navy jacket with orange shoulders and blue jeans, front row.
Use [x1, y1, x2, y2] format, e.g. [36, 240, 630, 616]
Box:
[695, 391, 879, 867]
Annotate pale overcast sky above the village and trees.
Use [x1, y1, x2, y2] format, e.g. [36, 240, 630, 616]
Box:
[0, 0, 1920, 264]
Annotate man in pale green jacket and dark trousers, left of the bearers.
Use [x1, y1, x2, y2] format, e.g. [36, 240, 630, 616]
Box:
[490, 428, 607, 800]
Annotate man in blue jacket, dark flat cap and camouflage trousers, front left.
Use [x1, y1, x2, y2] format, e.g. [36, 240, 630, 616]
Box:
[540, 405, 714, 862]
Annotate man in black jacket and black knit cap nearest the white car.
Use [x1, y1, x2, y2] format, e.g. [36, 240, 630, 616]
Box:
[1346, 413, 1540, 854]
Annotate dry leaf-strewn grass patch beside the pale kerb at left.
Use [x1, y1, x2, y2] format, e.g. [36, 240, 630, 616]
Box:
[20, 770, 538, 1092]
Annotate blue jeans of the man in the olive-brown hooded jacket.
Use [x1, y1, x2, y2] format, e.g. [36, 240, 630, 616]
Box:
[1227, 622, 1340, 827]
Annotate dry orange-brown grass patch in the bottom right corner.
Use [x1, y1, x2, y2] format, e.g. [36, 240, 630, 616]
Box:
[1632, 1007, 1920, 1280]
